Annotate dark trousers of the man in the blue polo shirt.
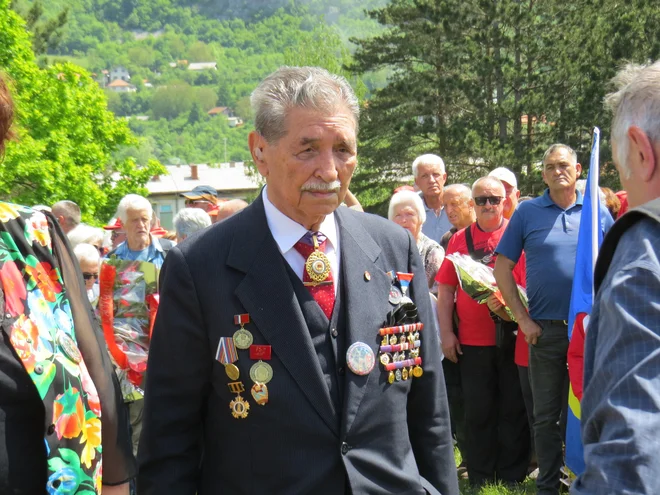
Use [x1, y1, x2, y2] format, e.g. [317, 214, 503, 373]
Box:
[529, 320, 568, 495]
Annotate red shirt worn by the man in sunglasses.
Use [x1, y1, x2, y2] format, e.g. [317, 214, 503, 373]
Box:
[435, 220, 525, 346]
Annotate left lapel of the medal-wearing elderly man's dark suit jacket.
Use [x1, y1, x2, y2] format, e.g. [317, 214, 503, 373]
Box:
[227, 196, 339, 435]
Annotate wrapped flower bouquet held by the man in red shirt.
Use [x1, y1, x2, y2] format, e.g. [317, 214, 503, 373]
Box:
[447, 253, 527, 321]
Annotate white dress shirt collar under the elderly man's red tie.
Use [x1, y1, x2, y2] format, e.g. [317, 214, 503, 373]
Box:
[263, 186, 339, 296]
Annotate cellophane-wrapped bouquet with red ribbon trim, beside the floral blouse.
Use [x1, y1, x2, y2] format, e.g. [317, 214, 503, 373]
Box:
[99, 256, 158, 401]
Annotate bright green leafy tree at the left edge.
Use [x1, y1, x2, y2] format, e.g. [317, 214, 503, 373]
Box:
[0, 0, 162, 221]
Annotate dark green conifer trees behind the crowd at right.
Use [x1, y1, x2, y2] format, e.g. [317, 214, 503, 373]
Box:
[351, 0, 659, 206]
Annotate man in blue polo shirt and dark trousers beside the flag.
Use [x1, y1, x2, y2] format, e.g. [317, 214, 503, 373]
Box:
[495, 144, 613, 495]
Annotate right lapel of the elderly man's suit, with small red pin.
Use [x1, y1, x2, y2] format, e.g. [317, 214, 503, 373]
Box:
[336, 208, 391, 434]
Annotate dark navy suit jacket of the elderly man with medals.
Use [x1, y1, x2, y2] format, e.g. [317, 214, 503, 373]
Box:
[138, 197, 458, 495]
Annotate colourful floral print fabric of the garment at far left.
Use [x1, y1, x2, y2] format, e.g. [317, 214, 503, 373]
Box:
[0, 202, 102, 495]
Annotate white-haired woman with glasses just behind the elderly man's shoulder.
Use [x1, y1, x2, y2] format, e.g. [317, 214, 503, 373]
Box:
[387, 191, 445, 295]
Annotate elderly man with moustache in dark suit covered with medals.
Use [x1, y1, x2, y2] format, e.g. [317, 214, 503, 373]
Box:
[138, 67, 458, 495]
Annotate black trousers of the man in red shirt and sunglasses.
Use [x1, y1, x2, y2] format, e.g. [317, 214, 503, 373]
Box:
[459, 346, 529, 485]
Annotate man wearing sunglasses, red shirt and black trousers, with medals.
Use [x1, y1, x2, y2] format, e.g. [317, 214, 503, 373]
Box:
[436, 177, 529, 486]
